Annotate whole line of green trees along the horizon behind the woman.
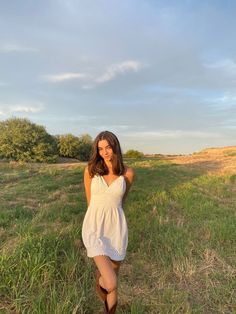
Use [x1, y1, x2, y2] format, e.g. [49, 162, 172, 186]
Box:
[0, 117, 143, 162]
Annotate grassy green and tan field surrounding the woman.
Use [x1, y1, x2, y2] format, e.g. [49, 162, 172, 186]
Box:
[0, 147, 236, 314]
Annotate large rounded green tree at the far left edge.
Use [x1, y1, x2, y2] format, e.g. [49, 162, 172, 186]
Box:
[0, 117, 57, 162]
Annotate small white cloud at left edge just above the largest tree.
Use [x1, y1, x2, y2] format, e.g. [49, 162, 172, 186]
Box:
[0, 103, 44, 115]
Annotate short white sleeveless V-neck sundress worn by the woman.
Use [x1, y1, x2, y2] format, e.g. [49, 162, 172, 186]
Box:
[82, 175, 128, 261]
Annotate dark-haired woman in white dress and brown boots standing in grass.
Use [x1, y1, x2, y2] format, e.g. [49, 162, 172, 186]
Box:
[82, 131, 134, 313]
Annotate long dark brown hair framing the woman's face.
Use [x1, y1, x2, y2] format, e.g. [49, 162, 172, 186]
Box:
[88, 131, 125, 177]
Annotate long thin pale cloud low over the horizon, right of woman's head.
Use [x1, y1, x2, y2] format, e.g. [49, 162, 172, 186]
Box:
[126, 130, 222, 140]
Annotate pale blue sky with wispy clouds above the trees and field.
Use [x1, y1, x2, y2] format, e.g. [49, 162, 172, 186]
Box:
[0, 0, 236, 154]
